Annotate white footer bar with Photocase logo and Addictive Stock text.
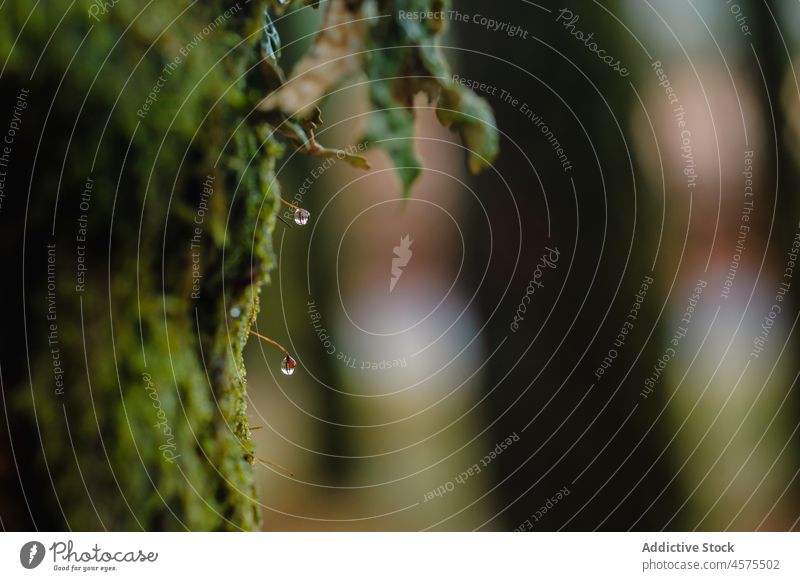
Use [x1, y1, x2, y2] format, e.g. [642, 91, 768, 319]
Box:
[0, 533, 800, 581]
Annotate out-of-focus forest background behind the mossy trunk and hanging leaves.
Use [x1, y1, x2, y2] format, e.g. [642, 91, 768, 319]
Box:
[0, 0, 800, 531]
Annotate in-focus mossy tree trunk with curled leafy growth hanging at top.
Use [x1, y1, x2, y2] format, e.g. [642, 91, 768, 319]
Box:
[0, 0, 497, 530]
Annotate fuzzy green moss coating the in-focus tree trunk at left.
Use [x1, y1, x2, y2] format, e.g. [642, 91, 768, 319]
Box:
[0, 1, 281, 530]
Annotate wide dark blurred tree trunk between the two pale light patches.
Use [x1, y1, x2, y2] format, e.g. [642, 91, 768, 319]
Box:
[462, 0, 674, 531]
